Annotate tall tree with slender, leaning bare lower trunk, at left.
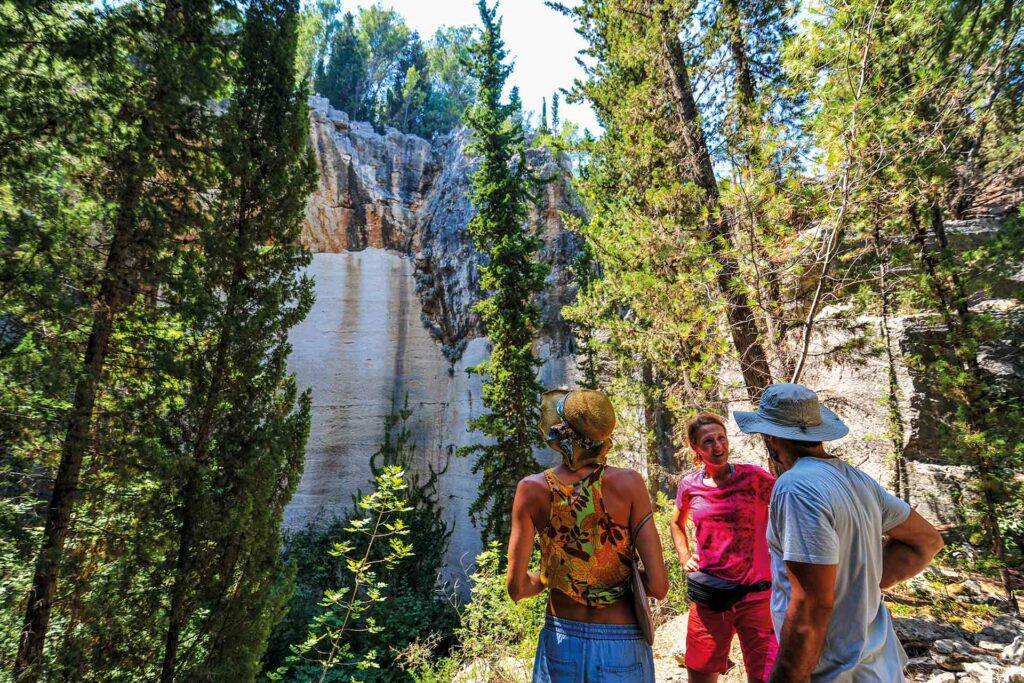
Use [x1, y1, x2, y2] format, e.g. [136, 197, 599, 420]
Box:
[15, 1, 223, 680]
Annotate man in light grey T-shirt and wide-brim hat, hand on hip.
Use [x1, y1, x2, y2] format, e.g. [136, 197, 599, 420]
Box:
[733, 384, 942, 683]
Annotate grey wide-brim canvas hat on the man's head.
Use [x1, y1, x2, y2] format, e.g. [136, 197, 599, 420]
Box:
[732, 384, 850, 441]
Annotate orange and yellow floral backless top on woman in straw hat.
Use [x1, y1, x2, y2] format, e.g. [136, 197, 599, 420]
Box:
[540, 465, 633, 607]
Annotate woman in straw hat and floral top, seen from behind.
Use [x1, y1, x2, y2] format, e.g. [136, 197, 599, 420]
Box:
[508, 389, 669, 683]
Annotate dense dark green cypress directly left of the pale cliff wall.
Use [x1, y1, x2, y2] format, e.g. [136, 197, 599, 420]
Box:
[154, 0, 315, 682]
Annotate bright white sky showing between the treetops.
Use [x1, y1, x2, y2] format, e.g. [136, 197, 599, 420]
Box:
[348, 0, 600, 134]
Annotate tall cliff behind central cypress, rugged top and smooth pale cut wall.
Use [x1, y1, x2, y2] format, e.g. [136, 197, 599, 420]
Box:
[285, 98, 581, 578]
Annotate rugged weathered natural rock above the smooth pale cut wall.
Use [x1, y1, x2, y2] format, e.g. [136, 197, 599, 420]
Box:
[302, 97, 583, 361]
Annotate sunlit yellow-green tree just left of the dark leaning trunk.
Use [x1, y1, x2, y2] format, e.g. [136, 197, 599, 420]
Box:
[562, 0, 764, 486]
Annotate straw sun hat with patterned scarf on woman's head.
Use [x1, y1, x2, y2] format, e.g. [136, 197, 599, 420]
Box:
[540, 389, 615, 469]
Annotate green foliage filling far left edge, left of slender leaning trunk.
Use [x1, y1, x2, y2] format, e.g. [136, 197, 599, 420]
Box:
[0, 1, 114, 669]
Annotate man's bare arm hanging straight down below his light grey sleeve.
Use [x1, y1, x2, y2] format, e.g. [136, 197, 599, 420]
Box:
[768, 562, 836, 683]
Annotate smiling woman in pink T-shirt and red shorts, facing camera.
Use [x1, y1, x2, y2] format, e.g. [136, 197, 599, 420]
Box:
[672, 413, 778, 683]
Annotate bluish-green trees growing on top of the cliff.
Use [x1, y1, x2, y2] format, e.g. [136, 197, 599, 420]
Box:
[307, 4, 475, 138]
